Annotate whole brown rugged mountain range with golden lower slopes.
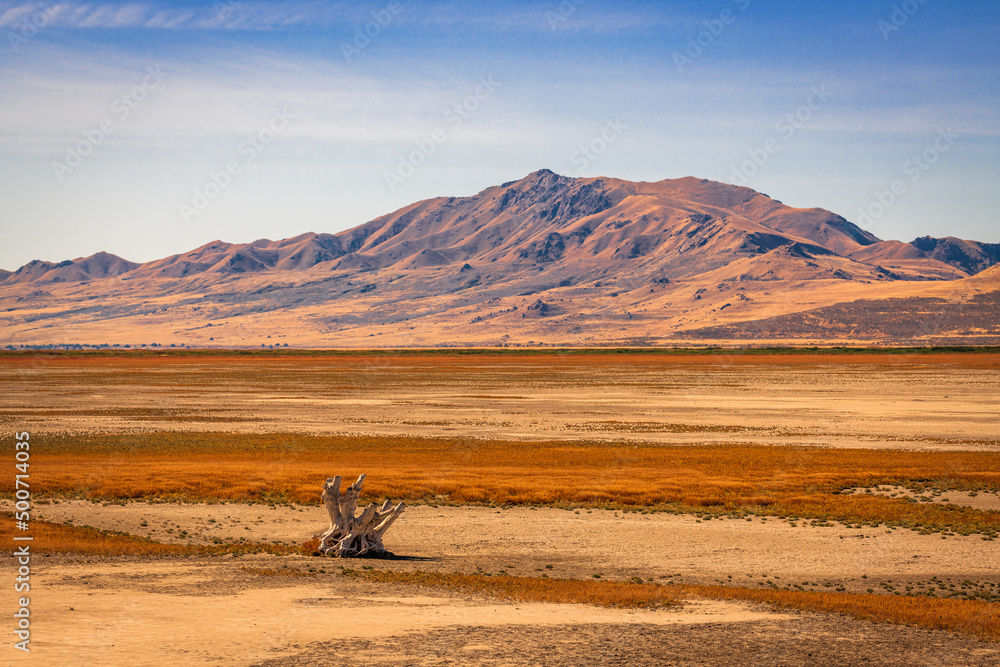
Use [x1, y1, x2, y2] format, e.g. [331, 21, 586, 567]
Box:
[0, 169, 1000, 347]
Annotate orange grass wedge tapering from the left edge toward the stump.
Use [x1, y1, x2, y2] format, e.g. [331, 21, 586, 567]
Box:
[0, 514, 302, 556]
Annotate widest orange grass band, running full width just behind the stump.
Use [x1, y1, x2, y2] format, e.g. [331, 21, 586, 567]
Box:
[13, 433, 1000, 539]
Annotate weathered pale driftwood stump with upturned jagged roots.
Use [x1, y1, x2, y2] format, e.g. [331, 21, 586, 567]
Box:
[319, 475, 405, 558]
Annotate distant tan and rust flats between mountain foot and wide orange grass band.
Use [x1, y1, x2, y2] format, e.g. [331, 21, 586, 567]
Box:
[0, 354, 1000, 451]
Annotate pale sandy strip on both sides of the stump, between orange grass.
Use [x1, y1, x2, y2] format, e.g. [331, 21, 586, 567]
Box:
[11, 501, 1000, 592]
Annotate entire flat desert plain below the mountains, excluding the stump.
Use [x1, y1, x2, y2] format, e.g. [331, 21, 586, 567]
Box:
[0, 350, 1000, 665]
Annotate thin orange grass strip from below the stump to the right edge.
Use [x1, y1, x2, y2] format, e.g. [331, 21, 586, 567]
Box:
[354, 571, 1000, 641]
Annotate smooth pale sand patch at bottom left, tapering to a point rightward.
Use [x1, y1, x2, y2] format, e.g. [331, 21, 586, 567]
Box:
[7, 556, 804, 665]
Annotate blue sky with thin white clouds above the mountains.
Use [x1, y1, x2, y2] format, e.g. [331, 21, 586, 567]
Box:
[0, 0, 1000, 270]
